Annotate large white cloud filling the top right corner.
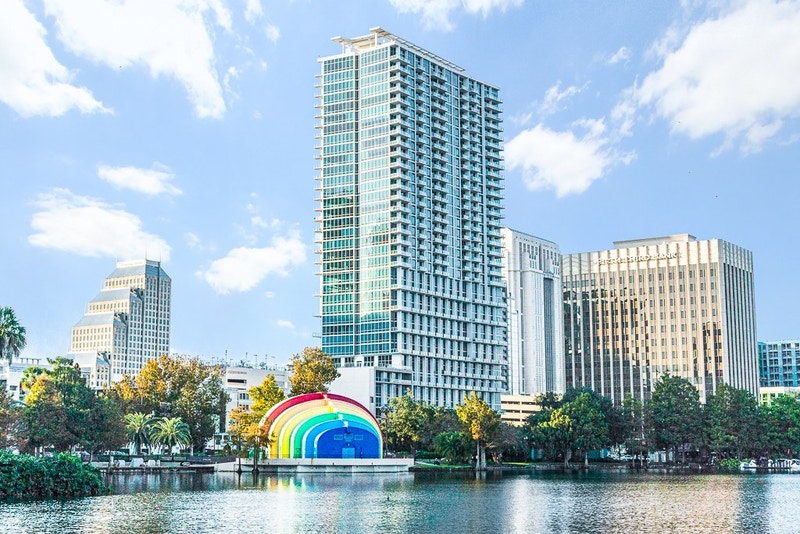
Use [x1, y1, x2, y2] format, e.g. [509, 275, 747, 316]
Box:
[632, 0, 800, 152]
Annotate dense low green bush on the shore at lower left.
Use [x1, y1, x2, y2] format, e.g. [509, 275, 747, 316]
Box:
[0, 452, 108, 500]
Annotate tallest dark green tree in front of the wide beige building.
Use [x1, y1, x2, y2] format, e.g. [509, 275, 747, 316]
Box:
[645, 374, 701, 461]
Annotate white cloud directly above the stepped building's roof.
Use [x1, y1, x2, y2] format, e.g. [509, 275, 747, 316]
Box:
[28, 189, 170, 261]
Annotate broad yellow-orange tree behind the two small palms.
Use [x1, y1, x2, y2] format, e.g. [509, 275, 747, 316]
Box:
[113, 354, 228, 451]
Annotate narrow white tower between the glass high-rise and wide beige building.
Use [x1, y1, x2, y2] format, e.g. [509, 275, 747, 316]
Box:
[502, 228, 565, 395]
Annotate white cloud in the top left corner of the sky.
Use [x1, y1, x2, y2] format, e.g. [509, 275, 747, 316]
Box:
[0, 0, 110, 117]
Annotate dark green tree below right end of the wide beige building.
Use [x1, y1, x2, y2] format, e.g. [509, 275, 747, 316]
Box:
[704, 384, 758, 458]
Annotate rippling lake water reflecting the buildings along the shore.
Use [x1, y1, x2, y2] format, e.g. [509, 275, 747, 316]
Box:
[0, 471, 800, 534]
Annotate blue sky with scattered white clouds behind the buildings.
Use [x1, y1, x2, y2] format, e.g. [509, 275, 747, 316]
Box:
[0, 0, 800, 363]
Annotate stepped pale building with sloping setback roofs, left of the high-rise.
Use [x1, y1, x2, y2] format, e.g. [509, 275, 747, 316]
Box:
[70, 260, 172, 387]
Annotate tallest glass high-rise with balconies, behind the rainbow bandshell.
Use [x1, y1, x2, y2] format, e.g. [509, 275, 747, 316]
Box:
[318, 28, 507, 411]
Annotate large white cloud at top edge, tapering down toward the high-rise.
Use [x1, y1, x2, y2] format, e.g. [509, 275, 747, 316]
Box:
[44, 0, 231, 118]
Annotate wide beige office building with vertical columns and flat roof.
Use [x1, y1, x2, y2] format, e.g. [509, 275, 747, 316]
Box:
[561, 234, 758, 402]
